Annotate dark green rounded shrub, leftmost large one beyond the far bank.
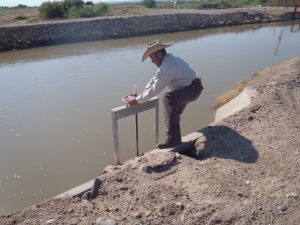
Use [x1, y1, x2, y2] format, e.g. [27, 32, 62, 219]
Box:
[39, 1, 65, 19]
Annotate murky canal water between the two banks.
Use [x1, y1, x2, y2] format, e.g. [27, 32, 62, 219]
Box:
[0, 21, 300, 213]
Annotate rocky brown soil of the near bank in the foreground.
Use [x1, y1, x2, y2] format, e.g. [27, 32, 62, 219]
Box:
[0, 57, 300, 225]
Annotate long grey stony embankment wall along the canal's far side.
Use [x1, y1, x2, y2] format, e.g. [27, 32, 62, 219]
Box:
[0, 12, 292, 51]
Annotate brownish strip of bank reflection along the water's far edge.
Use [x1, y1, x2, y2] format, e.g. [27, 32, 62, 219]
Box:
[0, 21, 300, 65]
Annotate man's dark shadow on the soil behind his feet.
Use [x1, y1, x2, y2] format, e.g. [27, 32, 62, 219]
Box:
[185, 126, 259, 163]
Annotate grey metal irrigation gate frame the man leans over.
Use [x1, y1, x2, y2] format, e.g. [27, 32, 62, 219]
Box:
[111, 97, 159, 164]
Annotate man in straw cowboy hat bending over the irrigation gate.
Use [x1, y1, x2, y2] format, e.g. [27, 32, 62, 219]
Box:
[128, 40, 203, 148]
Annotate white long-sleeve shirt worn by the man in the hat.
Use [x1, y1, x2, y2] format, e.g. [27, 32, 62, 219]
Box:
[136, 54, 197, 103]
